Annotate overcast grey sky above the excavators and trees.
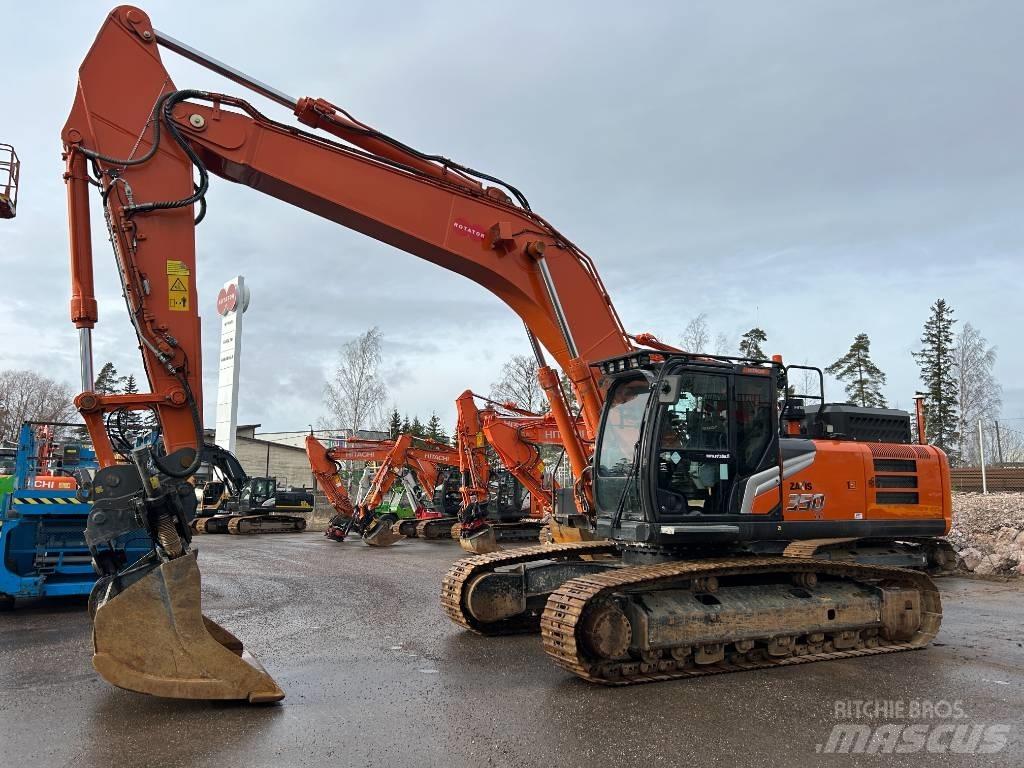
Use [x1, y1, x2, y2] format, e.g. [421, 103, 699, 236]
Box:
[0, 0, 1024, 430]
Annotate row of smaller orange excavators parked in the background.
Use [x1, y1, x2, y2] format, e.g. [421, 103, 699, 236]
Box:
[306, 390, 561, 553]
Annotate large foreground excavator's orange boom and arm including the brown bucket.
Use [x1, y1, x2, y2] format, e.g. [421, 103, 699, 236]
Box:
[61, 6, 663, 700]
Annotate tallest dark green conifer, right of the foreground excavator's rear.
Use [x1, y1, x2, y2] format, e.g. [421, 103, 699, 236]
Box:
[912, 299, 959, 456]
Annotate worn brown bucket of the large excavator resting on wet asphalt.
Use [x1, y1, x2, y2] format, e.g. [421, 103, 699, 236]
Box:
[92, 552, 285, 703]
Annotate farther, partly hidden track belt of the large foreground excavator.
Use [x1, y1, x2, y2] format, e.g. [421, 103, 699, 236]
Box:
[441, 542, 618, 635]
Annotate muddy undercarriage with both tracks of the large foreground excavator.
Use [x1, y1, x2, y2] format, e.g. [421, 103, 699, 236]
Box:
[441, 542, 942, 685]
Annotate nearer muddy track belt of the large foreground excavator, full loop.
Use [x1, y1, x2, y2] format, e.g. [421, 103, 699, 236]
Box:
[541, 557, 942, 685]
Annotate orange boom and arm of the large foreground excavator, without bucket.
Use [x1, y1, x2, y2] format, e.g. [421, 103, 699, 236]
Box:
[62, 6, 632, 479]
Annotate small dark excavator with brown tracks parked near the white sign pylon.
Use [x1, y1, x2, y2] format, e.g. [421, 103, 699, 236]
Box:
[191, 442, 305, 535]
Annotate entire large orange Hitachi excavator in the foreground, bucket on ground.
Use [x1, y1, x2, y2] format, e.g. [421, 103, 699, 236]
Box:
[61, 6, 951, 701]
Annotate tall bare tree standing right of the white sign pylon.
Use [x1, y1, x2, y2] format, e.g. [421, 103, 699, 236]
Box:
[324, 327, 387, 433]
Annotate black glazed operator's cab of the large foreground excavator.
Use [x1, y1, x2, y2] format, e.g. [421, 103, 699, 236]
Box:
[594, 353, 783, 546]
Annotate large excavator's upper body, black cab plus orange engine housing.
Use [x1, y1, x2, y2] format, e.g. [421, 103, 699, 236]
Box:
[594, 352, 948, 551]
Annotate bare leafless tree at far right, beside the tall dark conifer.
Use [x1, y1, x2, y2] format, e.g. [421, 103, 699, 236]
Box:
[953, 323, 1002, 465]
